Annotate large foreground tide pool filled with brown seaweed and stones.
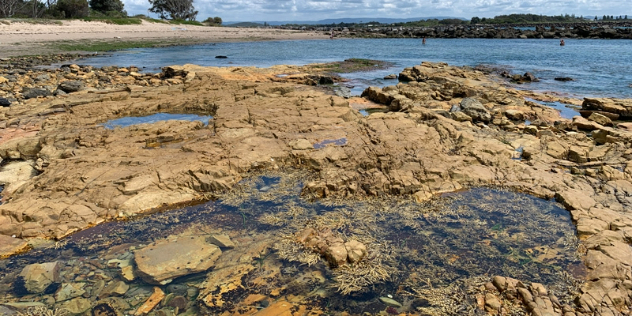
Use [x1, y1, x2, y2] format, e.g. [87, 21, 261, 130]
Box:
[0, 173, 583, 315]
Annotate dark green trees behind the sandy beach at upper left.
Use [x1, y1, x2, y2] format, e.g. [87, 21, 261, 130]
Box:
[0, 0, 222, 26]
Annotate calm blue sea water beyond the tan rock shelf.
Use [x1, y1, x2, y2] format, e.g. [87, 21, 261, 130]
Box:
[80, 39, 632, 98]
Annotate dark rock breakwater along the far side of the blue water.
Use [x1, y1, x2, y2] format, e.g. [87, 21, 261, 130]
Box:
[279, 22, 632, 39]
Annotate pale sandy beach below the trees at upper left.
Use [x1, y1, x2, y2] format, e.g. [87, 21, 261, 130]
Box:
[0, 20, 328, 57]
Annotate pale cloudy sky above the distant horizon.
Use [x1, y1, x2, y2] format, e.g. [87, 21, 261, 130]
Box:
[122, 0, 632, 22]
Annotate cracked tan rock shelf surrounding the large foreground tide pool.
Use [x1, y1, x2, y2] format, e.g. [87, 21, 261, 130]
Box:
[0, 58, 632, 316]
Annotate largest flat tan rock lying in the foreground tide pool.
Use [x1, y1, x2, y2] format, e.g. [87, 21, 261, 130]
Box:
[134, 236, 222, 285]
